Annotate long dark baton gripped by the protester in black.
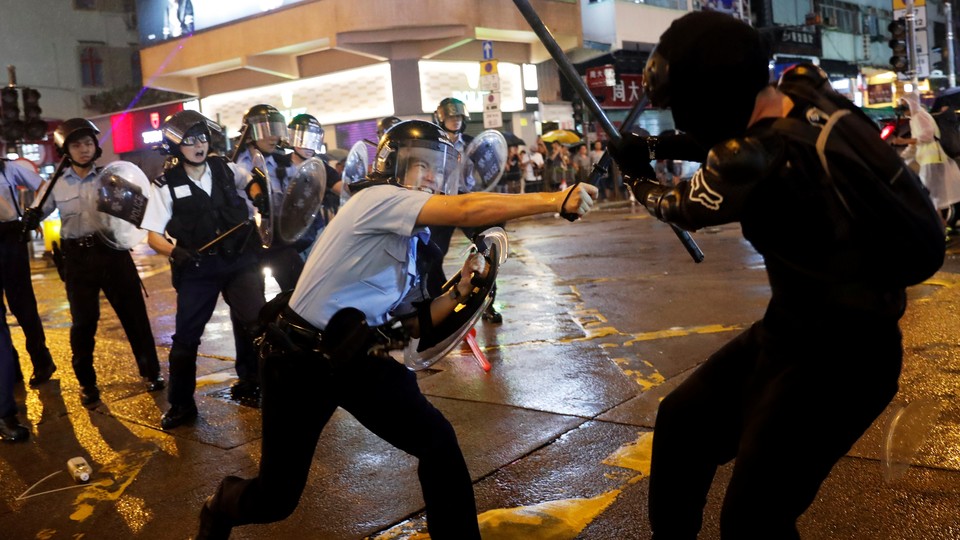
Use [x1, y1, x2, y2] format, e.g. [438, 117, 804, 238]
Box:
[513, 0, 703, 262]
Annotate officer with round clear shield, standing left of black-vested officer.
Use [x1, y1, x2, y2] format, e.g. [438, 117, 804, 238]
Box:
[23, 118, 165, 407]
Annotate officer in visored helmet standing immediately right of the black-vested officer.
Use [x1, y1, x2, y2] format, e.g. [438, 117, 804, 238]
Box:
[237, 104, 303, 291]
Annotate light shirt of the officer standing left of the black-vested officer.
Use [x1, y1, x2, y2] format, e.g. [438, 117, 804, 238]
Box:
[42, 167, 103, 238]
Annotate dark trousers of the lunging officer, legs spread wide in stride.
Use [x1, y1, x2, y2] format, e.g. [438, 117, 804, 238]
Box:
[213, 346, 480, 540]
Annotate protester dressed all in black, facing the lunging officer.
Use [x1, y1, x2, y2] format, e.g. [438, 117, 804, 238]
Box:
[614, 12, 906, 539]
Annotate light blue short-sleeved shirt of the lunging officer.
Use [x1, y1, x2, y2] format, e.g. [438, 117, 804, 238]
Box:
[290, 185, 431, 330]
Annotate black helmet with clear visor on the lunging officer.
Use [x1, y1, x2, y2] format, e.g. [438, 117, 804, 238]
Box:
[370, 120, 460, 194]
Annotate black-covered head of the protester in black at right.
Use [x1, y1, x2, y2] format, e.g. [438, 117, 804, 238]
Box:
[643, 11, 770, 148]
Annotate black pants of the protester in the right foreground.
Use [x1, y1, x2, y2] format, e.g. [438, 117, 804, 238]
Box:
[649, 320, 902, 540]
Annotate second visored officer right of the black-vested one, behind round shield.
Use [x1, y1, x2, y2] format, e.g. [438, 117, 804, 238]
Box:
[276, 114, 341, 260]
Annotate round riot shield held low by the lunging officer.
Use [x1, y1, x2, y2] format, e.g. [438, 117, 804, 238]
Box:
[403, 227, 509, 371]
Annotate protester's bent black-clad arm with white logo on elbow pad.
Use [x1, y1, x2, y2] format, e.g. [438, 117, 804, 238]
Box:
[626, 137, 783, 231]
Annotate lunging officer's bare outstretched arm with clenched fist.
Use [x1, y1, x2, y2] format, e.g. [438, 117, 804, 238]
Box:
[417, 183, 597, 227]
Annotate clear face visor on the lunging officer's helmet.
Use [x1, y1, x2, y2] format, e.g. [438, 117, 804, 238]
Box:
[396, 140, 460, 195]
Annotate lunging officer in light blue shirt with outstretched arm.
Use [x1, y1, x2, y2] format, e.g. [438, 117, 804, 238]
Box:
[197, 120, 596, 540]
